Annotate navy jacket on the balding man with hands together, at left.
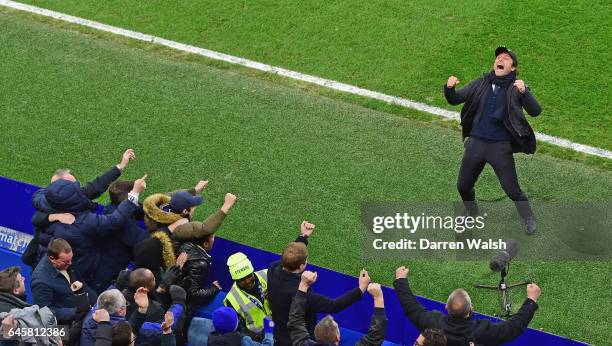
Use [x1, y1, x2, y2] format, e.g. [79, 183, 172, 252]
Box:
[31, 257, 98, 324]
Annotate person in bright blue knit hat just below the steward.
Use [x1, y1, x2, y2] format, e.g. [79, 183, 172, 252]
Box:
[208, 306, 274, 346]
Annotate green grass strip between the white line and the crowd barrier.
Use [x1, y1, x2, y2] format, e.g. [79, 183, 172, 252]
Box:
[0, 4, 612, 344]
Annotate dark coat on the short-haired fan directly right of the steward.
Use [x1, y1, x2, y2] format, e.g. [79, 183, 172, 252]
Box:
[268, 236, 363, 345]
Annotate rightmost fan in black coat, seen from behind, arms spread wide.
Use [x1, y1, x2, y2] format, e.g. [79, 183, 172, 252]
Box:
[393, 266, 541, 346]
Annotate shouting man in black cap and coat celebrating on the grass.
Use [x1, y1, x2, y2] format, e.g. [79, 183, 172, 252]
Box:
[444, 47, 542, 234]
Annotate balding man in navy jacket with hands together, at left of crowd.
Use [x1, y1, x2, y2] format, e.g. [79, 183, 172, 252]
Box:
[31, 239, 97, 324]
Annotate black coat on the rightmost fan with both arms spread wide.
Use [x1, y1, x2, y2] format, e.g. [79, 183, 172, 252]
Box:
[393, 279, 538, 346]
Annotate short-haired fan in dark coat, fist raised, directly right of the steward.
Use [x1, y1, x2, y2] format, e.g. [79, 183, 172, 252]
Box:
[268, 221, 370, 346]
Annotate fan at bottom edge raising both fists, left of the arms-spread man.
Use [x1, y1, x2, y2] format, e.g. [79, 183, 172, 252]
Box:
[287, 271, 387, 346]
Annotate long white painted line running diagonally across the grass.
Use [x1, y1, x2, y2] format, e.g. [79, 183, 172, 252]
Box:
[0, 0, 612, 159]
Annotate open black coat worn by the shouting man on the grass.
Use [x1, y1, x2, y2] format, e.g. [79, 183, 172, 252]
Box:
[444, 73, 542, 154]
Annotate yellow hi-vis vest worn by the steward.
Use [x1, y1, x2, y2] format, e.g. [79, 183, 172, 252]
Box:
[225, 269, 272, 333]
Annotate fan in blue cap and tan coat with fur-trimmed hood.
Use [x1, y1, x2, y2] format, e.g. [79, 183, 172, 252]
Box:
[134, 180, 208, 282]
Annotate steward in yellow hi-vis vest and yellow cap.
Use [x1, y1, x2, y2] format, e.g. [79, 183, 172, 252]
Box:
[223, 252, 272, 340]
